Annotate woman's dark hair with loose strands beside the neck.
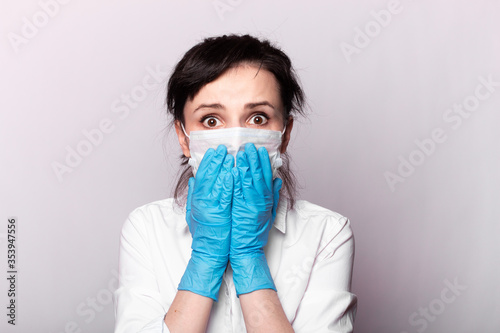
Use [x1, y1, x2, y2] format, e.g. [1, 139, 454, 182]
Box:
[165, 35, 305, 208]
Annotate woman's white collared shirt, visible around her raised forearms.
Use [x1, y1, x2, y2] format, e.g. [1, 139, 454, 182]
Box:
[114, 199, 357, 333]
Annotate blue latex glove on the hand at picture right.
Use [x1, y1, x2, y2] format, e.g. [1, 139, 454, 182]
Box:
[229, 143, 282, 296]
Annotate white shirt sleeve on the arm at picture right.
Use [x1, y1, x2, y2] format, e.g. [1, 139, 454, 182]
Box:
[292, 217, 357, 333]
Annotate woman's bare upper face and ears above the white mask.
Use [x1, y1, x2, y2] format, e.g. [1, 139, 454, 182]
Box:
[175, 64, 293, 157]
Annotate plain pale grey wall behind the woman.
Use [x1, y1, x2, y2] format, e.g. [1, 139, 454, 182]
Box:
[0, 0, 500, 333]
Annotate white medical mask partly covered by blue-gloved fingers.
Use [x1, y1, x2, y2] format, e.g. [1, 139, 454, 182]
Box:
[181, 124, 286, 178]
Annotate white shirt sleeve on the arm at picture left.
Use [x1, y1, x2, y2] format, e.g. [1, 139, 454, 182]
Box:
[114, 211, 170, 333]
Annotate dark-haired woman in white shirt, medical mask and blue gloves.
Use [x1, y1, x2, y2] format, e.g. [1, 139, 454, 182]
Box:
[115, 35, 356, 333]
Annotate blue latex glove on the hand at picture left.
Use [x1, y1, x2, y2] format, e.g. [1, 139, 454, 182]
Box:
[178, 145, 234, 301]
